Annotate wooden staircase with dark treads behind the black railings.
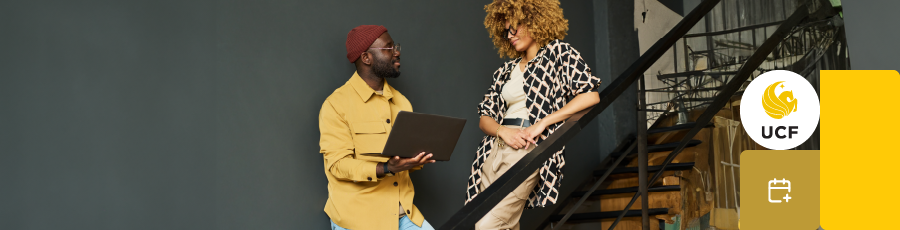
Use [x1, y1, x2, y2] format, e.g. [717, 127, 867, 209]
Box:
[537, 118, 712, 230]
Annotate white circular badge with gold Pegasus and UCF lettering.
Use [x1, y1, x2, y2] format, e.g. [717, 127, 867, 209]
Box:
[741, 70, 819, 150]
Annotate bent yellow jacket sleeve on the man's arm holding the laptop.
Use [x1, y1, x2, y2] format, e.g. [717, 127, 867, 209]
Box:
[319, 100, 380, 181]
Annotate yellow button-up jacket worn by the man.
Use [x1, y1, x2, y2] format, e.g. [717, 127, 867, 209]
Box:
[319, 73, 425, 230]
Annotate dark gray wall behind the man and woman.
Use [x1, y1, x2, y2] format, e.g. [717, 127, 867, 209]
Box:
[0, 0, 599, 229]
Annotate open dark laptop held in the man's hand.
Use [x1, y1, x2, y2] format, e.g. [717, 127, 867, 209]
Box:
[381, 111, 466, 161]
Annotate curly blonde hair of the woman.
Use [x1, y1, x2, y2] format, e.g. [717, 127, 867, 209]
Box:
[484, 0, 569, 58]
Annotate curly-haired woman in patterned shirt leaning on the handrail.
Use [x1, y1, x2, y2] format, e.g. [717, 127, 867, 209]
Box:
[466, 0, 600, 229]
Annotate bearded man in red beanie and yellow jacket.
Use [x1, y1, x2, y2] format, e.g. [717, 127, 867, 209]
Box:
[319, 25, 434, 230]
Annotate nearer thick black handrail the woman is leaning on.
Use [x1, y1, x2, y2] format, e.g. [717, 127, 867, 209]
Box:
[439, 0, 720, 230]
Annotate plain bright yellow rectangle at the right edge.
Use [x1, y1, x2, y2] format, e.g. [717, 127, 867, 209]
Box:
[820, 70, 900, 230]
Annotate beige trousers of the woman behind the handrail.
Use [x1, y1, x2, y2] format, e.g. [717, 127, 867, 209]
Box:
[475, 126, 540, 230]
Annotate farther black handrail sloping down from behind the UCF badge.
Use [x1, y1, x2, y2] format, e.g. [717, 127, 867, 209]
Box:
[609, 0, 827, 230]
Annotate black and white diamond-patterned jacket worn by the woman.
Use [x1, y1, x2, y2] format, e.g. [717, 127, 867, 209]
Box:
[466, 39, 600, 208]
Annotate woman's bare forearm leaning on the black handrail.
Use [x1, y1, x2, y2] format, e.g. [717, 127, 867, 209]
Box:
[520, 92, 600, 145]
